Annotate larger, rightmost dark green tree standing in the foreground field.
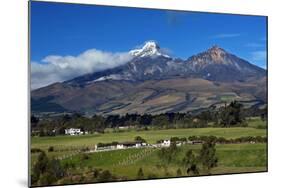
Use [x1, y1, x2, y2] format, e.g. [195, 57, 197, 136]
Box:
[200, 140, 218, 171]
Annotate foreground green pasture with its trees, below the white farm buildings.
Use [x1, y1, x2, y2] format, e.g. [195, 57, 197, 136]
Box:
[30, 144, 267, 185]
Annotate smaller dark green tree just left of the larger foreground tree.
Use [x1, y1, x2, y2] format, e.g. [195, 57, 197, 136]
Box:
[182, 150, 199, 175]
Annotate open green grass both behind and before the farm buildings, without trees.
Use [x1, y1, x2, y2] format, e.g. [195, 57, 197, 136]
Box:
[31, 118, 267, 184]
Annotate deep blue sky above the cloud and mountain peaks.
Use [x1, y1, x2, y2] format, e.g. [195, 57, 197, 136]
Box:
[31, 2, 266, 89]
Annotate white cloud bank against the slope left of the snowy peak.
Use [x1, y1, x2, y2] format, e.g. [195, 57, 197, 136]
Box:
[31, 49, 132, 89]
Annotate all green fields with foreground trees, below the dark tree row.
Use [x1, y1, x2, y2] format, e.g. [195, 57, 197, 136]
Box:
[31, 117, 267, 185]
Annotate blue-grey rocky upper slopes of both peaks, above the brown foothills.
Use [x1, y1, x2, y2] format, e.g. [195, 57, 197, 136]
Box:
[63, 41, 266, 85]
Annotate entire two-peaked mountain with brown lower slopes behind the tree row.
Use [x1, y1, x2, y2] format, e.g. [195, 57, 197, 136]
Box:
[31, 41, 267, 115]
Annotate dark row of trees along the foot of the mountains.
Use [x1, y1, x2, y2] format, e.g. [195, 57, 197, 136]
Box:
[31, 101, 267, 136]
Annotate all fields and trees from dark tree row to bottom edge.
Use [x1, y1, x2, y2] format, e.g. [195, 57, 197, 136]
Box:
[31, 101, 267, 186]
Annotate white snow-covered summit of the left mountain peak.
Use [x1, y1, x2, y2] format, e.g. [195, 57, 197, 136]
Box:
[129, 41, 170, 58]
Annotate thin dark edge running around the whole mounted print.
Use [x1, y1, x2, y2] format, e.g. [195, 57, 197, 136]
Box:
[27, 0, 269, 188]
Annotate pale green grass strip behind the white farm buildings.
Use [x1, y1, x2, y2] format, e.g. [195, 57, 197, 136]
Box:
[31, 127, 266, 150]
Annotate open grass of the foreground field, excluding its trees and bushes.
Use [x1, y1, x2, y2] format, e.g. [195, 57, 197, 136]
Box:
[30, 144, 267, 184]
